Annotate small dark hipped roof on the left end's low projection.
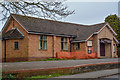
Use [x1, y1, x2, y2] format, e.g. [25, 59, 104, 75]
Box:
[2, 28, 24, 39]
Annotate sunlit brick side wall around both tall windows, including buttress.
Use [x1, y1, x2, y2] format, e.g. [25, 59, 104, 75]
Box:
[28, 34, 70, 60]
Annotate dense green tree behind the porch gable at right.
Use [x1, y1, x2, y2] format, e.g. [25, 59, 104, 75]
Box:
[105, 14, 120, 42]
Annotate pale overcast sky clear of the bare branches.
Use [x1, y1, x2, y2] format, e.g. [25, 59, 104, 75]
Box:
[0, 0, 119, 30]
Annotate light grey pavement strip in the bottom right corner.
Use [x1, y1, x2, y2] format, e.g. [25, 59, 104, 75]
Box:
[54, 69, 120, 78]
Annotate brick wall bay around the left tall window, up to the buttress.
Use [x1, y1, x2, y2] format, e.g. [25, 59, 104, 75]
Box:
[28, 34, 53, 58]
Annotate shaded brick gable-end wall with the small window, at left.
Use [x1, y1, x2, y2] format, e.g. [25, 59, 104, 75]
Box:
[2, 19, 28, 61]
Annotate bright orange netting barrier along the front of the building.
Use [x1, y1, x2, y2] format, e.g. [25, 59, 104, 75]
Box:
[56, 51, 98, 59]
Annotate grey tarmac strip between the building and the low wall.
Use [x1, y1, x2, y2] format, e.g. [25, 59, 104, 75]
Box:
[2, 58, 120, 71]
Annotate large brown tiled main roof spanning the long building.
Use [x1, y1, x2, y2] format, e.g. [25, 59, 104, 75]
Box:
[12, 14, 106, 41]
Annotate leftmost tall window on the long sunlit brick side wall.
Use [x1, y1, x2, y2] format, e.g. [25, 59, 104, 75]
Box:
[39, 35, 47, 50]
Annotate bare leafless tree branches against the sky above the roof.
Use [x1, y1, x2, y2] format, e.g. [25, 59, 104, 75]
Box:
[0, 0, 74, 21]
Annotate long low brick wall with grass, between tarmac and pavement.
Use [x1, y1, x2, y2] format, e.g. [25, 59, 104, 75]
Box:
[2, 62, 120, 78]
